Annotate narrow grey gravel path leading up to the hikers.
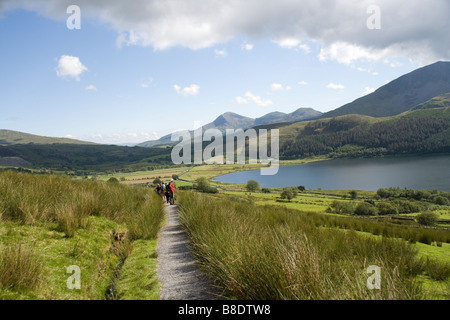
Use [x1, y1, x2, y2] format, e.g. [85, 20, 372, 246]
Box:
[156, 205, 220, 300]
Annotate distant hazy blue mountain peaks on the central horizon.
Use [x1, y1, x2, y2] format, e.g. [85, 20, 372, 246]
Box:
[137, 108, 322, 148]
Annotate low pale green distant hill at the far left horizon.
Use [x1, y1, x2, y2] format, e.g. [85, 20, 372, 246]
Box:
[0, 130, 95, 146]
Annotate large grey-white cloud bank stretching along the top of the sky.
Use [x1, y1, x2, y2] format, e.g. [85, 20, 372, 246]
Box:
[0, 0, 450, 64]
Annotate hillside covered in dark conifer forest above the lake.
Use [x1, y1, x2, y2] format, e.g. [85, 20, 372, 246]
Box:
[280, 107, 450, 159]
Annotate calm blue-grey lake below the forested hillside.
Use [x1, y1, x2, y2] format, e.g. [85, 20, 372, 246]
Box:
[214, 155, 450, 191]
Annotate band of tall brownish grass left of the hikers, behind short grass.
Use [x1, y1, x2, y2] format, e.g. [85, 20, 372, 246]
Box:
[0, 172, 164, 239]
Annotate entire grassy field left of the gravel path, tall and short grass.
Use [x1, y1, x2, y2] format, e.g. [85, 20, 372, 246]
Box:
[0, 172, 164, 300]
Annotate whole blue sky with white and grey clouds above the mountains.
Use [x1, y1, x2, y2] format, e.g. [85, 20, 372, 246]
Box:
[0, 0, 450, 144]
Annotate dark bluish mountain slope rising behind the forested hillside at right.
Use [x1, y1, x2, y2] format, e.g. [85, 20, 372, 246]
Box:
[322, 61, 450, 118]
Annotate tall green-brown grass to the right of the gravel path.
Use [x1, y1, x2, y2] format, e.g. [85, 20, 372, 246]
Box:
[180, 193, 422, 300]
